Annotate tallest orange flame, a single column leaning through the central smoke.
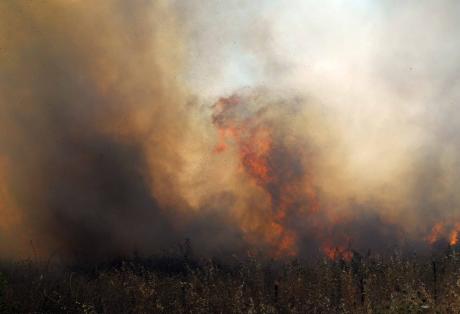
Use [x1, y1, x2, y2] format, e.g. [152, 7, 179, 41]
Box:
[213, 95, 315, 256]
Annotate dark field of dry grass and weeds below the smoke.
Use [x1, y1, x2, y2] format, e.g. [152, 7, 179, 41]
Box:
[0, 248, 460, 313]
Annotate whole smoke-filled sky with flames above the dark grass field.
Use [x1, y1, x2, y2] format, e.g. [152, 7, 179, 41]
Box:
[0, 0, 460, 258]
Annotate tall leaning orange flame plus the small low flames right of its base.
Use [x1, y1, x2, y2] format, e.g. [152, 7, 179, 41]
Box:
[213, 95, 353, 260]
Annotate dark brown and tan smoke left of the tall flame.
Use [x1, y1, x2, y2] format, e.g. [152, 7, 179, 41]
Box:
[0, 1, 244, 256]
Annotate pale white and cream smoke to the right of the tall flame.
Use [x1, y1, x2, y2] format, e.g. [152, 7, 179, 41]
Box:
[180, 1, 460, 256]
